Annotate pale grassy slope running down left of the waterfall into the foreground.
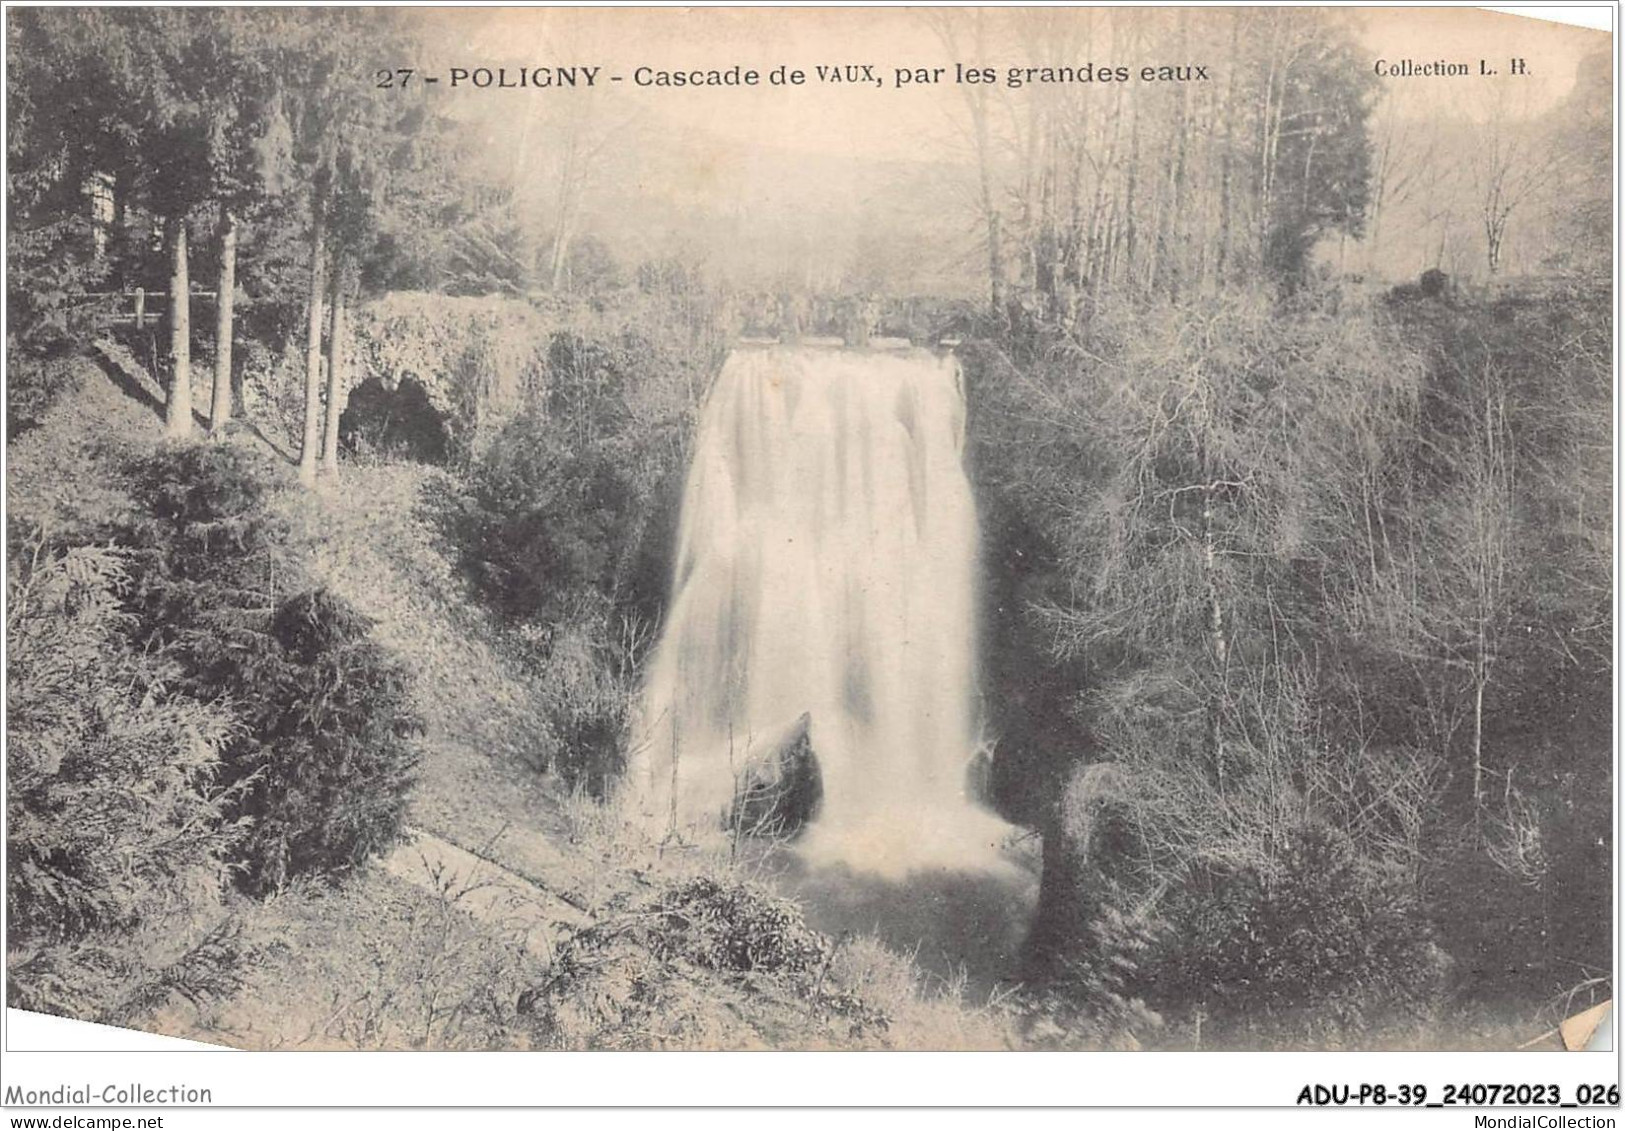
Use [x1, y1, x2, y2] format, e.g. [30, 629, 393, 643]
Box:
[7, 362, 1016, 1048]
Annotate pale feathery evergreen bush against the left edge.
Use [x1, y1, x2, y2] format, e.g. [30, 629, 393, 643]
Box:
[7, 535, 244, 1017]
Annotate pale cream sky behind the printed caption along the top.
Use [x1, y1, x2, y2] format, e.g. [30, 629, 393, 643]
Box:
[419, 8, 1607, 159]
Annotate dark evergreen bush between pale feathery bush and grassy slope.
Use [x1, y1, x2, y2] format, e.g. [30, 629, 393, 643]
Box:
[115, 444, 423, 894]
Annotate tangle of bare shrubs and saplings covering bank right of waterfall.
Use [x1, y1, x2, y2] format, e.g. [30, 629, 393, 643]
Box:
[972, 281, 1610, 1045]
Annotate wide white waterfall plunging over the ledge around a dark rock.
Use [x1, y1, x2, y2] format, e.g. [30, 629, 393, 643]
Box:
[629, 346, 1009, 876]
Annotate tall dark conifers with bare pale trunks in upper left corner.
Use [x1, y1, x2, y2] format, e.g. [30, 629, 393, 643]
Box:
[7, 8, 515, 458]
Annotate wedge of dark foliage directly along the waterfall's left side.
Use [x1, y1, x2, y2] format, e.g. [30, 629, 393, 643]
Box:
[432, 293, 720, 790]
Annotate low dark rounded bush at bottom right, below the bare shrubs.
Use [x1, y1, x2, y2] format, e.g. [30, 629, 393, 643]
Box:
[1144, 824, 1445, 1048]
